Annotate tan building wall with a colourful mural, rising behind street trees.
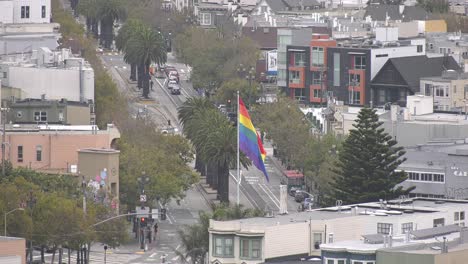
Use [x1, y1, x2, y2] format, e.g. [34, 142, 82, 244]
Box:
[78, 148, 120, 210]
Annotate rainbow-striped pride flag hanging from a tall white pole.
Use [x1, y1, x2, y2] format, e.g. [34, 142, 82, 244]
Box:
[238, 98, 270, 181]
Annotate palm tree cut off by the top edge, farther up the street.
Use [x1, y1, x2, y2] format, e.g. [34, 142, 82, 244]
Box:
[97, 0, 127, 49]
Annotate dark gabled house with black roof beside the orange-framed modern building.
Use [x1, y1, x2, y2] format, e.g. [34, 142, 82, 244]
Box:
[370, 55, 460, 106]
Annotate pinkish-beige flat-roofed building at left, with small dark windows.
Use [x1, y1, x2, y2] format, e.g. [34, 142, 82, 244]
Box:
[0, 124, 120, 173]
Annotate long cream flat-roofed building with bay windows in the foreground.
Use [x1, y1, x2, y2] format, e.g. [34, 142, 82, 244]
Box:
[208, 198, 468, 264]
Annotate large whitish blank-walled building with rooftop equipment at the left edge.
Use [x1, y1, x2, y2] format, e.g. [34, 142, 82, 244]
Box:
[0, 48, 94, 102]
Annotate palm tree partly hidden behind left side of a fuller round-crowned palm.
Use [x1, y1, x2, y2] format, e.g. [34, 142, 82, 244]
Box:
[115, 19, 144, 81]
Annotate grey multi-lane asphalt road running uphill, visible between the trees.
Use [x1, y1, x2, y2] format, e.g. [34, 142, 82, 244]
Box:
[100, 50, 299, 264]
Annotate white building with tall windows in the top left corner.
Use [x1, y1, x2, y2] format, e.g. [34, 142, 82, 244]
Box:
[0, 0, 51, 24]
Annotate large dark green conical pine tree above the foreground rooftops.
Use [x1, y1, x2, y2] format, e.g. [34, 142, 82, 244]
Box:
[332, 108, 414, 204]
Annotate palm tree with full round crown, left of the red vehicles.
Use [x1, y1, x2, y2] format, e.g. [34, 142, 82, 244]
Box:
[124, 25, 167, 98]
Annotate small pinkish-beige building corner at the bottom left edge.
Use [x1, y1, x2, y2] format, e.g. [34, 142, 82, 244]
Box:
[0, 236, 26, 264]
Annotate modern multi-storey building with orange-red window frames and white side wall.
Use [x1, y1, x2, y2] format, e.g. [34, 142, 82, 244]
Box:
[327, 27, 425, 105]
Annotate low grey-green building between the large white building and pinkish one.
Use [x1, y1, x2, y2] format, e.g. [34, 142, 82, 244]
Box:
[7, 99, 95, 125]
